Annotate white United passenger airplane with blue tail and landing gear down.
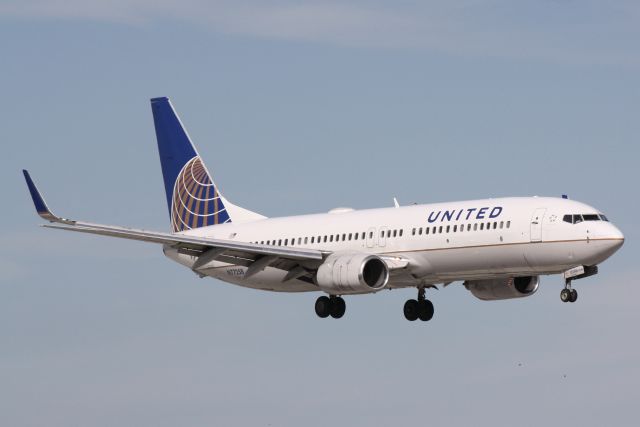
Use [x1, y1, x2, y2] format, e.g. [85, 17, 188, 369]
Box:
[23, 97, 624, 321]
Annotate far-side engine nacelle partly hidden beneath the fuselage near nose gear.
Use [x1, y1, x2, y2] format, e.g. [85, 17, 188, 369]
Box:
[464, 276, 540, 301]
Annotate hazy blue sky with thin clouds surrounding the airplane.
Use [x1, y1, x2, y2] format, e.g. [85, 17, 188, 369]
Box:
[0, 0, 640, 426]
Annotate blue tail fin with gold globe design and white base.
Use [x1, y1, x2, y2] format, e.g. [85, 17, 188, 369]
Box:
[151, 97, 265, 232]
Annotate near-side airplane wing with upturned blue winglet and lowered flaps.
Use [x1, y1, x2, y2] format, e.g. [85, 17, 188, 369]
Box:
[23, 170, 329, 278]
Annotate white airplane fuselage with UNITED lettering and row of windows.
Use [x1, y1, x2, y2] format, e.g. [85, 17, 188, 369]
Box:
[165, 197, 624, 292]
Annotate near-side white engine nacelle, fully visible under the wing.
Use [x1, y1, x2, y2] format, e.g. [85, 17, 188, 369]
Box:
[316, 253, 389, 295]
